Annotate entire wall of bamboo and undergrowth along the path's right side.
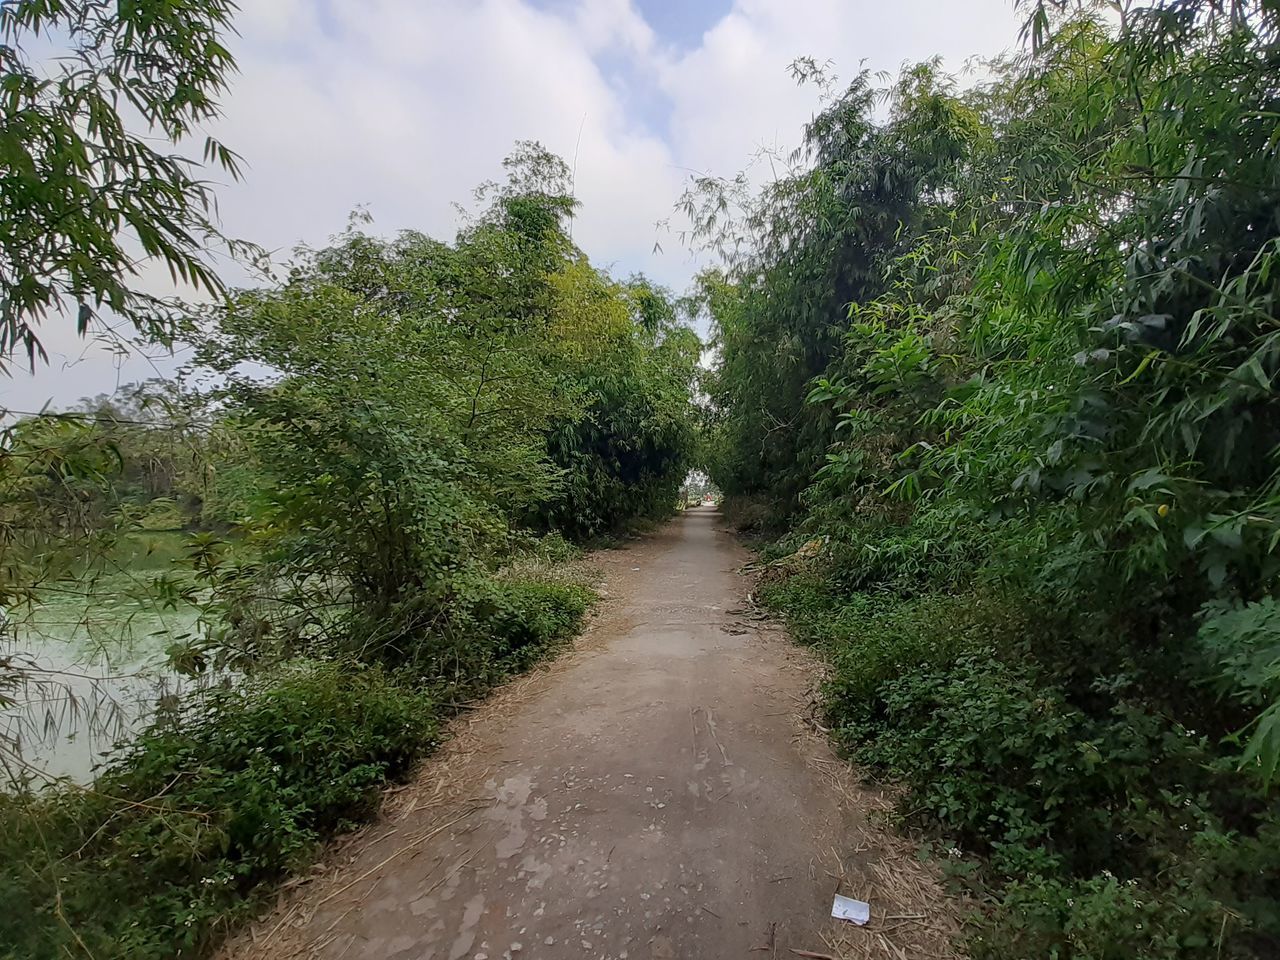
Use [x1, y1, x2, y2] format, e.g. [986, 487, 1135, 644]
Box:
[694, 0, 1280, 957]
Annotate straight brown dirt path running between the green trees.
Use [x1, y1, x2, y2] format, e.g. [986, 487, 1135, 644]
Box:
[227, 508, 955, 960]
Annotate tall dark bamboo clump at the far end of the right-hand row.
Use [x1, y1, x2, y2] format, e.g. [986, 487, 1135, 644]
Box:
[682, 64, 980, 527]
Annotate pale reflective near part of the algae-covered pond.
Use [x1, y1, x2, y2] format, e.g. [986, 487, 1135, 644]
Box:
[0, 600, 195, 783]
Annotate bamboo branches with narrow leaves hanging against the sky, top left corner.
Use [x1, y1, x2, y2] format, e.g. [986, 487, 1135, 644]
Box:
[0, 0, 251, 365]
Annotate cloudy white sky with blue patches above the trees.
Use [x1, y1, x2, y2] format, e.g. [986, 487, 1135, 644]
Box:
[0, 0, 1018, 411]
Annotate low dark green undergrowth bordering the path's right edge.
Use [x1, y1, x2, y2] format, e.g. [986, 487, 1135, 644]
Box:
[762, 570, 1280, 960]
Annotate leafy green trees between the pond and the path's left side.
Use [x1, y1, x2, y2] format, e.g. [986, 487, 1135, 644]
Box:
[183, 143, 698, 669]
